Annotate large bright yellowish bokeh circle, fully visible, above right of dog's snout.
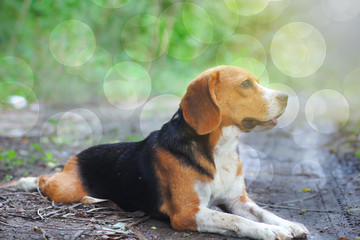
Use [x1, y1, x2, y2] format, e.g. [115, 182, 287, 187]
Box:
[271, 22, 326, 77]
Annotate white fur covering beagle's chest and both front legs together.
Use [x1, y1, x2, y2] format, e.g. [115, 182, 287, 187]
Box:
[195, 126, 309, 240]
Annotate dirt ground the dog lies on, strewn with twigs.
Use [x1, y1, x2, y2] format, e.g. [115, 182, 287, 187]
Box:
[0, 107, 360, 240]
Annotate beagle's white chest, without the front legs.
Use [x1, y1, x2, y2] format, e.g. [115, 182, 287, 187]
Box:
[195, 127, 245, 205]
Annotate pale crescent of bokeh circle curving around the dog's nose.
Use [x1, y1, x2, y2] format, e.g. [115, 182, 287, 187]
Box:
[269, 83, 300, 128]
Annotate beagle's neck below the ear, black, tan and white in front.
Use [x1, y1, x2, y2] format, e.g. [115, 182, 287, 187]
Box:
[158, 109, 241, 177]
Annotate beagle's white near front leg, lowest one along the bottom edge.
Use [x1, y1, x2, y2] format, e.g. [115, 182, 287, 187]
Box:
[196, 206, 292, 240]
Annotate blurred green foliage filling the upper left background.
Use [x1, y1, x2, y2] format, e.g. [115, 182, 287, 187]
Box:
[0, 0, 290, 107]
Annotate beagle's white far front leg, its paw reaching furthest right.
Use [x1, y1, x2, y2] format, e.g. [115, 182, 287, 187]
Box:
[227, 198, 310, 238]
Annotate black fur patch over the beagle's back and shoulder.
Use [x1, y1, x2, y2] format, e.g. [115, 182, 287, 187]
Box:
[77, 109, 214, 213]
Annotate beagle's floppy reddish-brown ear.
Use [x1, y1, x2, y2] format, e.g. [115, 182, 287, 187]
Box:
[180, 72, 221, 135]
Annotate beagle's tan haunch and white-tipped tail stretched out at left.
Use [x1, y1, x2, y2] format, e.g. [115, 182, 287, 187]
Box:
[0, 156, 88, 203]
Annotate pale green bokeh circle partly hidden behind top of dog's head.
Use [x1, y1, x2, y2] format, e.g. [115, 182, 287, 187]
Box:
[216, 34, 266, 66]
